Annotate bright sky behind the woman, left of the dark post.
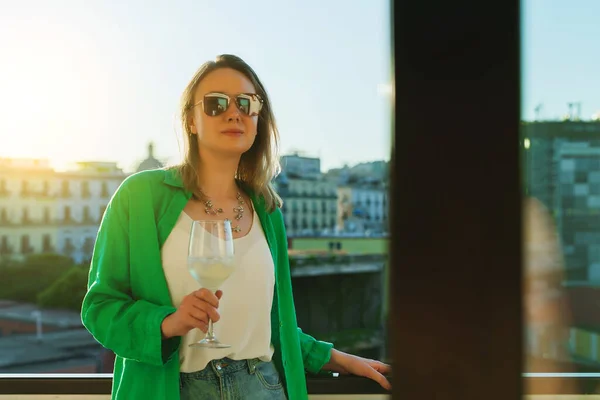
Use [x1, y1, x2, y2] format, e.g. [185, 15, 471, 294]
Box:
[0, 0, 392, 170]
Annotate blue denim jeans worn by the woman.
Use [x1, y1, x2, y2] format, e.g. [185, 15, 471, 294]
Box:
[179, 358, 286, 400]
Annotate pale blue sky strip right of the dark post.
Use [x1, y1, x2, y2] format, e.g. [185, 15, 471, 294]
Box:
[521, 0, 600, 120]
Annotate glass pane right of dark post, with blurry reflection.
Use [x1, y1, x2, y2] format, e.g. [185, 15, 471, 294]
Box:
[520, 0, 600, 390]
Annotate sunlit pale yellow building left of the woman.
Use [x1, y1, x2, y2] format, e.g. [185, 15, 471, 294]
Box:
[0, 158, 126, 263]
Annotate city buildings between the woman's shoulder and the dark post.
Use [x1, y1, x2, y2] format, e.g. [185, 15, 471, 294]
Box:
[275, 153, 389, 237]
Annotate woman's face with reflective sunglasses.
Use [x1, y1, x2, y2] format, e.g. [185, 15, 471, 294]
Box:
[190, 68, 258, 156]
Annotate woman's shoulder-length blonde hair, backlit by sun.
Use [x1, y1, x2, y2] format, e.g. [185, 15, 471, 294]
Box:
[174, 54, 282, 212]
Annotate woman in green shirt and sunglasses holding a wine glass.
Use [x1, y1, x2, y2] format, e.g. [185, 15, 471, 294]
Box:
[82, 55, 390, 400]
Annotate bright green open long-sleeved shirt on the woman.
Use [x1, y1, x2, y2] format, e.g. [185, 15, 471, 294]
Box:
[81, 169, 332, 400]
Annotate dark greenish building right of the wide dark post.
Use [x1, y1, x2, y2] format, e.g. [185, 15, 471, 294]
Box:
[522, 121, 600, 282]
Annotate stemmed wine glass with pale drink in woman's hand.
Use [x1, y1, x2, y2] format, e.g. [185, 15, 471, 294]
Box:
[188, 220, 235, 349]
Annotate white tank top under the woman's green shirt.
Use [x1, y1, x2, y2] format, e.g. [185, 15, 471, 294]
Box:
[161, 212, 275, 372]
